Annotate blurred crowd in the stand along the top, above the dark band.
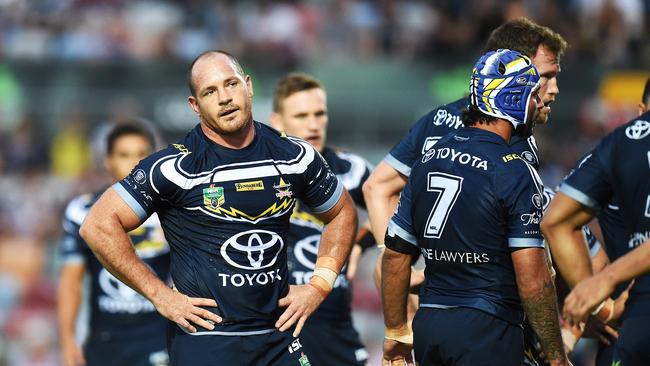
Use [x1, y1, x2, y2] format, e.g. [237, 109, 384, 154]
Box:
[0, 0, 650, 66]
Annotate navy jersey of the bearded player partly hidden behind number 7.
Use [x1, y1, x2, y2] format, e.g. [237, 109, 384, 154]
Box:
[384, 98, 539, 176]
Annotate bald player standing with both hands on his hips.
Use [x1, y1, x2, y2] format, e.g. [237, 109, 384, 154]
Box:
[80, 51, 357, 366]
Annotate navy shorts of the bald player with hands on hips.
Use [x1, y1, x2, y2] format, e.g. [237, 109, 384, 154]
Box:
[168, 324, 310, 366]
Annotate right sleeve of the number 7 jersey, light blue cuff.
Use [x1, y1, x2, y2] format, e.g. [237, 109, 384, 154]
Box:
[496, 159, 544, 249]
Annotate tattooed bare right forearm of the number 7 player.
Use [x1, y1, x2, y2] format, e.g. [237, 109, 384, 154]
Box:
[512, 248, 569, 365]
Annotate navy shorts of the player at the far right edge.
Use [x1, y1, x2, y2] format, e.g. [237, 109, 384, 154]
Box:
[612, 316, 650, 366]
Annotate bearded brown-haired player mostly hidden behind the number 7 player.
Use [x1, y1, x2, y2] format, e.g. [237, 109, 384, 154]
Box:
[363, 18, 576, 365]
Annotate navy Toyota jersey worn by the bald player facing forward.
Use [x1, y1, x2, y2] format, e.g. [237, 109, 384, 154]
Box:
[114, 122, 343, 335]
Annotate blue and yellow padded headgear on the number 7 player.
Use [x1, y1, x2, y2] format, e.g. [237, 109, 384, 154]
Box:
[469, 49, 539, 128]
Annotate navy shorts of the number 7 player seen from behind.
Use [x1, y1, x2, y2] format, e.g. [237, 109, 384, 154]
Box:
[413, 307, 524, 366]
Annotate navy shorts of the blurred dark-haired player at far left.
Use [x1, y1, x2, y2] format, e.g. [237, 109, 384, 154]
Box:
[83, 329, 169, 366]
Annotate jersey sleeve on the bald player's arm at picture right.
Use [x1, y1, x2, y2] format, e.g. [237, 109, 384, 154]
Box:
[301, 143, 344, 214]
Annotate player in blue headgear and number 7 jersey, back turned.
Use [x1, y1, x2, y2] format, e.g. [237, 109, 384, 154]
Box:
[382, 49, 569, 366]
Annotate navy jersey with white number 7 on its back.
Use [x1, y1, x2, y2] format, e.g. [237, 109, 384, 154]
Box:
[388, 128, 544, 324]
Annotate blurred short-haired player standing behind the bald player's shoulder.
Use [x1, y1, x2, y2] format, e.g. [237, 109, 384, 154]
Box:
[271, 73, 374, 365]
